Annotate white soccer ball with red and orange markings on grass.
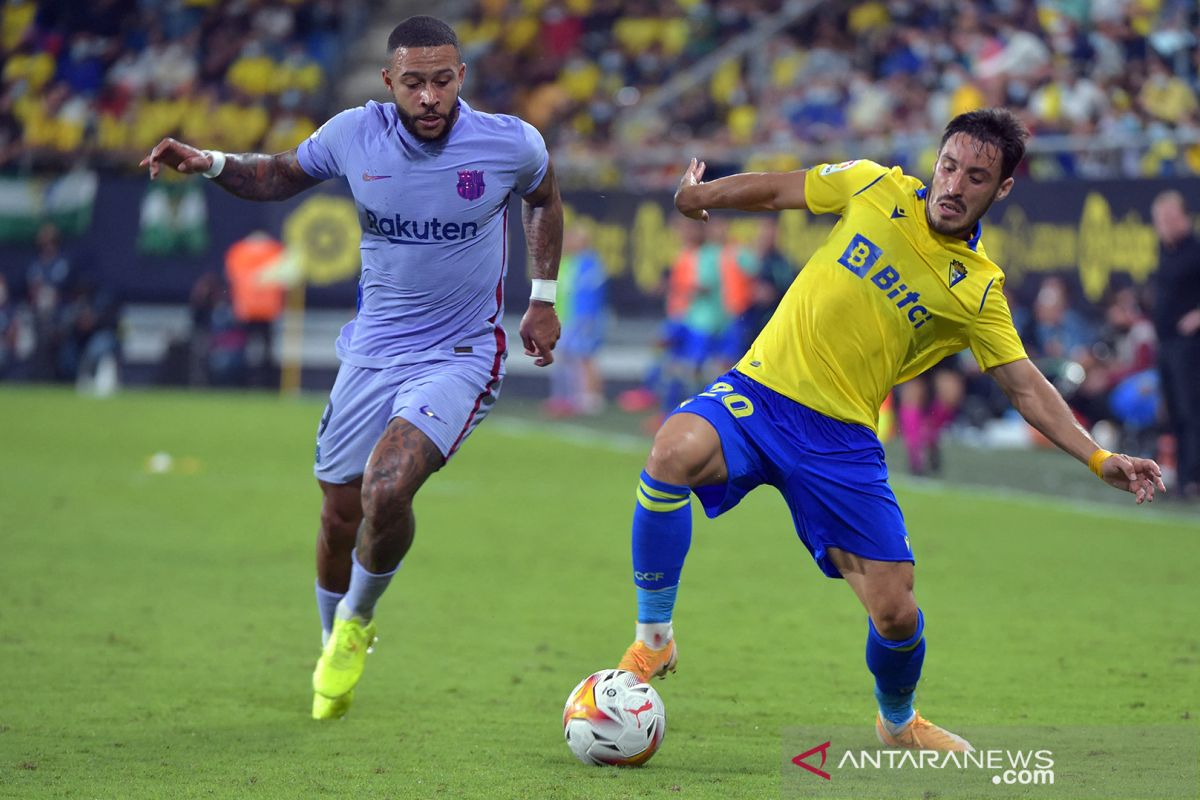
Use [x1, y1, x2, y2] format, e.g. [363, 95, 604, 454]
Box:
[563, 669, 667, 766]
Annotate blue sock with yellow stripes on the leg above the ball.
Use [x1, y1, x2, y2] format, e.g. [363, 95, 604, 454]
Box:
[634, 470, 691, 622]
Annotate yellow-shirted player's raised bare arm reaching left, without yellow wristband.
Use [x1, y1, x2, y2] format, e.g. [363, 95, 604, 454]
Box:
[676, 158, 808, 221]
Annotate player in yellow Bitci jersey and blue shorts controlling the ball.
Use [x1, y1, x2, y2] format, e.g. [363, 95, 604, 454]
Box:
[620, 108, 1165, 750]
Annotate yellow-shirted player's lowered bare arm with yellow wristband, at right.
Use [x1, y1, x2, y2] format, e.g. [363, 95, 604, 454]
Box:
[989, 359, 1166, 504]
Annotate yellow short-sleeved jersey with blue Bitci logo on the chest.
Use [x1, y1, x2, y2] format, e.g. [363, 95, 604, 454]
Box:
[737, 161, 1025, 429]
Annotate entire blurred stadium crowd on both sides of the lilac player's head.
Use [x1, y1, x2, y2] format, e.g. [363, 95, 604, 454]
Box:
[0, 0, 1200, 182]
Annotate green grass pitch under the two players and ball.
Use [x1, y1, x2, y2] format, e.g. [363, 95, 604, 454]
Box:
[0, 389, 1200, 799]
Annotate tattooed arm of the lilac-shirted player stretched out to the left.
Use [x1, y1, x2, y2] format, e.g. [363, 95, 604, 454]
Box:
[138, 138, 320, 200]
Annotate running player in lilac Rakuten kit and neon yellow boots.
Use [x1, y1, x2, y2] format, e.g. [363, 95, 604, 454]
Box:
[142, 17, 563, 718]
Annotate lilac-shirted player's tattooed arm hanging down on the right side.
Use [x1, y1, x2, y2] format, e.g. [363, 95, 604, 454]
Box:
[521, 163, 563, 367]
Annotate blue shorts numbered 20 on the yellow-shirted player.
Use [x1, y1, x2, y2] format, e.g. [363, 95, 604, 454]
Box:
[672, 369, 916, 578]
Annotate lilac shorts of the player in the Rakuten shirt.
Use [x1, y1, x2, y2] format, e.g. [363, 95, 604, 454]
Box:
[313, 354, 504, 483]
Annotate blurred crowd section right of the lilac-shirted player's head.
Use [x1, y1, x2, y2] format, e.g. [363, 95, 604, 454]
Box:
[460, 0, 1200, 180]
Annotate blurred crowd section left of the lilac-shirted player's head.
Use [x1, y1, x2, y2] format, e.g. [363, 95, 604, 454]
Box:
[0, 0, 362, 172]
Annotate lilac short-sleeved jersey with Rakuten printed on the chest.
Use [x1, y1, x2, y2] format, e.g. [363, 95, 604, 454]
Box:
[296, 100, 550, 368]
